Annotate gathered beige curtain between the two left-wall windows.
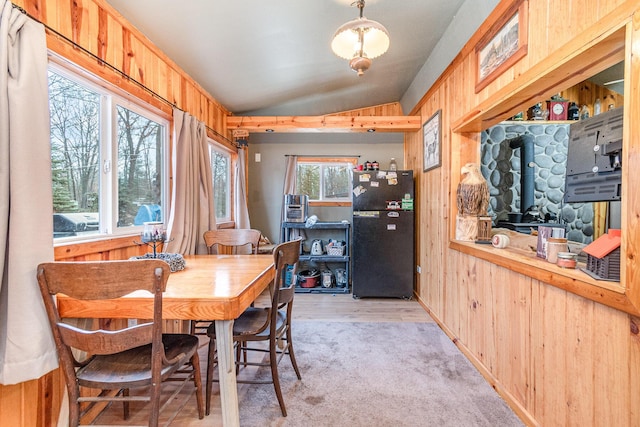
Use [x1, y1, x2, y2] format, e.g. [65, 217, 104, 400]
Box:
[167, 109, 216, 255]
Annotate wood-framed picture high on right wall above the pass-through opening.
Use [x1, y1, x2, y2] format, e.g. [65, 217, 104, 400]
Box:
[475, 0, 529, 93]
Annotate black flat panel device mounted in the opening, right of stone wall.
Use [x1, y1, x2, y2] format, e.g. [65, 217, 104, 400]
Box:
[564, 107, 623, 203]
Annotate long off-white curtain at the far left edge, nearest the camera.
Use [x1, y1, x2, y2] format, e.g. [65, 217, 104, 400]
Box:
[0, 0, 58, 384]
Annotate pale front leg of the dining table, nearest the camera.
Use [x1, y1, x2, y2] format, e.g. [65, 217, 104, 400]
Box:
[215, 320, 240, 427]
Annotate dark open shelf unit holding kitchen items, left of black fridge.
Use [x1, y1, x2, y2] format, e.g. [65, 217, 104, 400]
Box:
[281, 221, 351, 294]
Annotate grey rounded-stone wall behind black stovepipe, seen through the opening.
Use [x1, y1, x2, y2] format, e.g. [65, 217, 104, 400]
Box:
[480, 121, 593, 243]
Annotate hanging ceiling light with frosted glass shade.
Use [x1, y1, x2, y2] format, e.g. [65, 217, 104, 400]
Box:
[331, 0, 389, 76]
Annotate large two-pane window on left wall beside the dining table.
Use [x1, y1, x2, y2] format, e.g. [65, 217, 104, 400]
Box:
[49, 64, 169, 240]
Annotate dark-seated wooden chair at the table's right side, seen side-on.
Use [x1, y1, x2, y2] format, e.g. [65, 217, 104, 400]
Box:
[206, 239, 302, 417]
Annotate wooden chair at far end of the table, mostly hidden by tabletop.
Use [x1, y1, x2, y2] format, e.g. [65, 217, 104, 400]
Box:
[191, 228, 262, 335]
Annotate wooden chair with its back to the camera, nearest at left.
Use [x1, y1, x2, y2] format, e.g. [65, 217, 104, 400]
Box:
[37, 259, 204, 426]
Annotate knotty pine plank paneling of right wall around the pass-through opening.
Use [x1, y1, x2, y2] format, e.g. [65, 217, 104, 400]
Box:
[408, 0, 640, 425]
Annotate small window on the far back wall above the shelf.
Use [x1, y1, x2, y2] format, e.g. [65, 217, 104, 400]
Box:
[296, 158, 357, 204]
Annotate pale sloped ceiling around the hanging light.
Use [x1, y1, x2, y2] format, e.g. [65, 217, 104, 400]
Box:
[107, 0, 464, 115]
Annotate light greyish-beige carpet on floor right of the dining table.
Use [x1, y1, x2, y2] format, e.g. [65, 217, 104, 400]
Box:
[214, 321, 523, 427]
